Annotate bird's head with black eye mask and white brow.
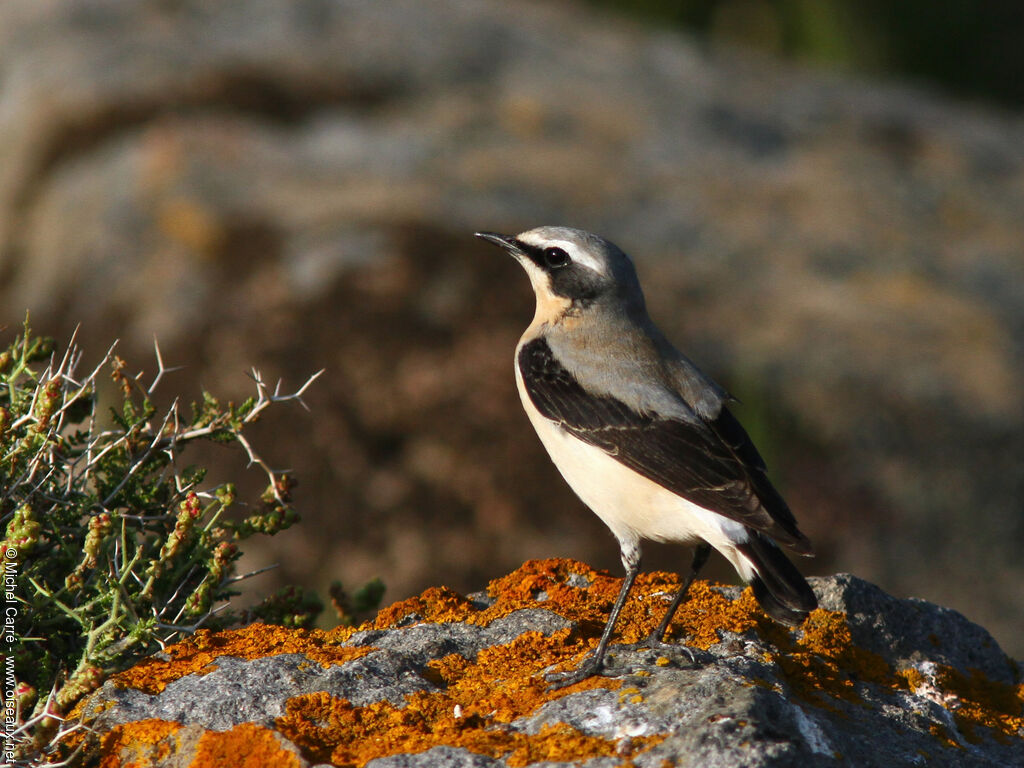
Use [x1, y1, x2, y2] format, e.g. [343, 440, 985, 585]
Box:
[476, 226, 643, 319]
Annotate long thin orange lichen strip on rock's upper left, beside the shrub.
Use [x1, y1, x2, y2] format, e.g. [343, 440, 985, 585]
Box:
[111, 624, 374, 694]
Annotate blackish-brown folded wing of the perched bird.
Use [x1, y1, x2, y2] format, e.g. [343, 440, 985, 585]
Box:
[518, 339, 811, 553]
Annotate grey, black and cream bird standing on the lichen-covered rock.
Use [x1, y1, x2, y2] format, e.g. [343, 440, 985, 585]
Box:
[475, 226, 817, 687]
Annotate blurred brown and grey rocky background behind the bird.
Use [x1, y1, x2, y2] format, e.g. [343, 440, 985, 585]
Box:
[0, 0, 1024, 656]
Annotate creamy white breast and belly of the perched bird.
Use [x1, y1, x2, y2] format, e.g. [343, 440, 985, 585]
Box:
[515, 365, 755, 582]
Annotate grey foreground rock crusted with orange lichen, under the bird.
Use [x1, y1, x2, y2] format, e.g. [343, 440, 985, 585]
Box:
[78, 560, 1024, 768]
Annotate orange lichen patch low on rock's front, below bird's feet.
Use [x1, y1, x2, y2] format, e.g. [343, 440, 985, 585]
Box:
[275, 630, 665, 766]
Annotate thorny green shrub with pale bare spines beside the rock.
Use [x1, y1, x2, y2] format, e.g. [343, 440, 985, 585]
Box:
[0, 323, 322, 765]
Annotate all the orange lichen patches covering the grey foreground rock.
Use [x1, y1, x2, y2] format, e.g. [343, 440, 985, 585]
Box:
[74, 560, 1024, 768]
